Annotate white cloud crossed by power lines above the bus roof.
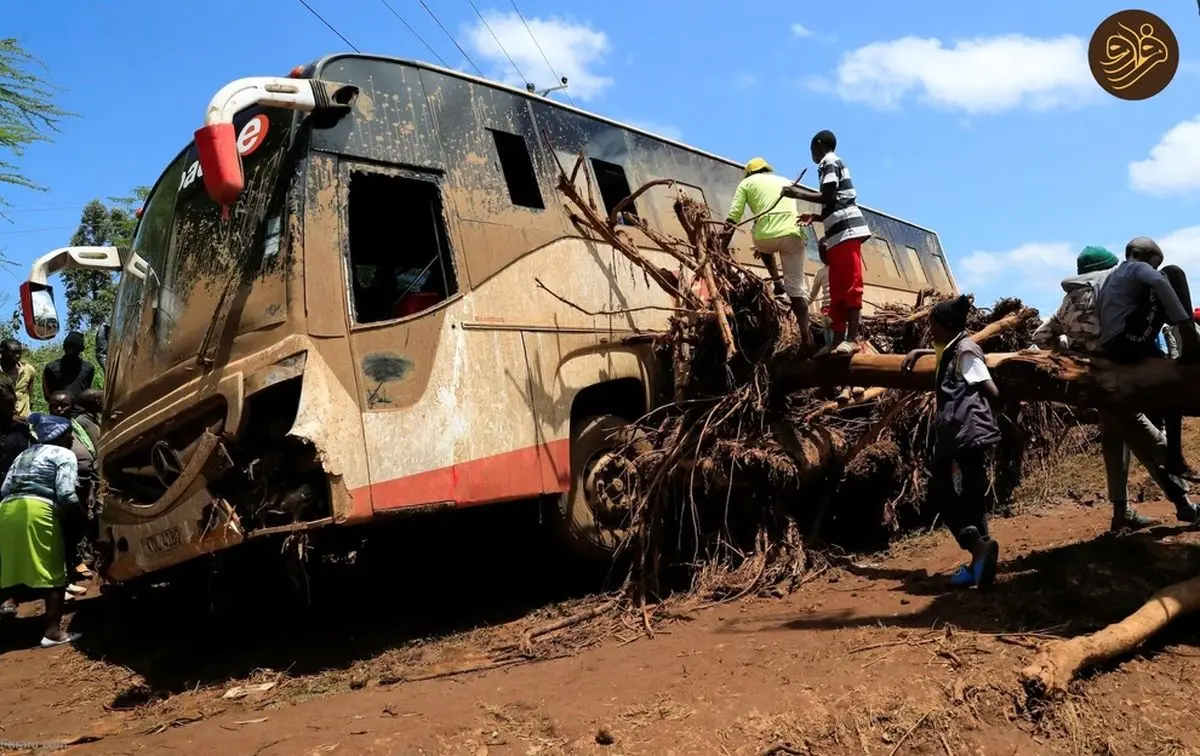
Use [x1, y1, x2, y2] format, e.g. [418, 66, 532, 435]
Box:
[467, 12, 612, 101]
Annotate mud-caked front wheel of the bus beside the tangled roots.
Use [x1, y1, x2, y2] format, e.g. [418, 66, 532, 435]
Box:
[552, 414, 649, 562]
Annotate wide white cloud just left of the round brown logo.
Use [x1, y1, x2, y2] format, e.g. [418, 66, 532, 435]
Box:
[835, 35, 1099, 114]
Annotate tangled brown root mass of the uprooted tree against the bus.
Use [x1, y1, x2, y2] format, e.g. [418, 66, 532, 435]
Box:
[544, 149, 1076, 614]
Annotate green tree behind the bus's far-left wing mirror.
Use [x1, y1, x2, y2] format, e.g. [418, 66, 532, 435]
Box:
[61, 186, 150, 331]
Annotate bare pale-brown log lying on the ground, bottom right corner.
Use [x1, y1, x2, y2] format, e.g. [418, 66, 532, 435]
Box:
[1021, 577, 1200, 697]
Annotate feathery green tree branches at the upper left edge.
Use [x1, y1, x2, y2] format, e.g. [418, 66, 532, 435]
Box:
[0, 37, 71, 206]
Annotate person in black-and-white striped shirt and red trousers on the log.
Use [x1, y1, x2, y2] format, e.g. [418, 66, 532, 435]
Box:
[784, 130, 871, 356]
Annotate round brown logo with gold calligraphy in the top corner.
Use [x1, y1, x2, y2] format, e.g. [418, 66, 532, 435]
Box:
[1087, 11, 1180, 100]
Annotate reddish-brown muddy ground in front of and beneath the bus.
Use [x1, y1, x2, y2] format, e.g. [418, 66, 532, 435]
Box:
[0, 424, 1200, 756]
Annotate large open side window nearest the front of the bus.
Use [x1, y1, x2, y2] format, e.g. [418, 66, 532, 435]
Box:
[348, 170, 458, 323]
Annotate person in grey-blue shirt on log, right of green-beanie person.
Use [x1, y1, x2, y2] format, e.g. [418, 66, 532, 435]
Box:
[1096, 236, 1200, 530]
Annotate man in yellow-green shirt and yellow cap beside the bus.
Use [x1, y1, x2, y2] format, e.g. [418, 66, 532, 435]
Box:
[726, 157, 811, 343]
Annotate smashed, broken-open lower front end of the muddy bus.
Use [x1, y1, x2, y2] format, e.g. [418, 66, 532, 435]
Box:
[96, 353, 349, 582]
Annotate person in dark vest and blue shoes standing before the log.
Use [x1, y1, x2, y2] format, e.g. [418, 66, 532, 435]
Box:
[900, 295, 1000, 590]
